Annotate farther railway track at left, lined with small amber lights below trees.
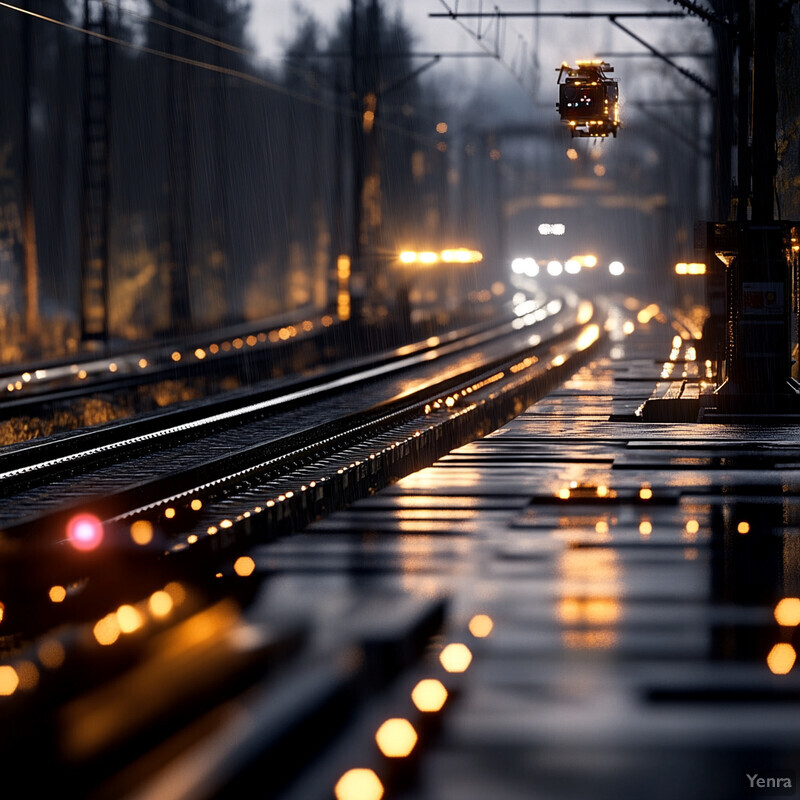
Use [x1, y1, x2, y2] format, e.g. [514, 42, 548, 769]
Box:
[0, 308, 492, 421]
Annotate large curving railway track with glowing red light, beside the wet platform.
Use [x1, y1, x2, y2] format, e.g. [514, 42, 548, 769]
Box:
[0, 290, 603, 797]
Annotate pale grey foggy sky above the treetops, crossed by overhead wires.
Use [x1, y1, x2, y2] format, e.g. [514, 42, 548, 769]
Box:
[249, 0, 708, 97]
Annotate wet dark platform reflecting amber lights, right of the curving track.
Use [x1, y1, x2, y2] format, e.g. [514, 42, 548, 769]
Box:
[144, 323, 800, 800]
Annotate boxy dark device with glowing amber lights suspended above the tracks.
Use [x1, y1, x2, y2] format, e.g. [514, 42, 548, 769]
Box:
[556, 61, 620, 138]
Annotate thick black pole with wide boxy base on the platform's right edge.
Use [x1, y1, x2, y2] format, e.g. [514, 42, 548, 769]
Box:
[716, 0, 800, 412]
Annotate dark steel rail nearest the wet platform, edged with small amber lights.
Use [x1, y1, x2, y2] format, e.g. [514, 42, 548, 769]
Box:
[0, 298, 600, 627]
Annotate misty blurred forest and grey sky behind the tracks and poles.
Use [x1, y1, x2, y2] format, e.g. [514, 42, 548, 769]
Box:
[0, 0, 800, 362]
